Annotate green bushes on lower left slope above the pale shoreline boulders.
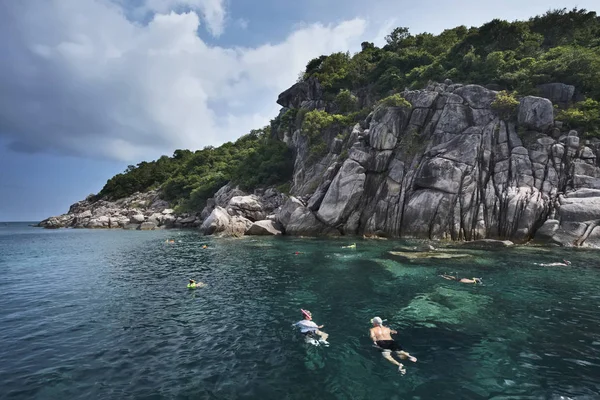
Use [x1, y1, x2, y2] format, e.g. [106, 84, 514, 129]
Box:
[97, 127, 293, 211]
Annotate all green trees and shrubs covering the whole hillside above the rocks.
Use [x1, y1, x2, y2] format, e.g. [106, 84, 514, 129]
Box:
[98, 9, 600, 211]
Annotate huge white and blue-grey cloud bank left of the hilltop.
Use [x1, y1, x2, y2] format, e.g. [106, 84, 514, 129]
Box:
[0, 0, 366, 161]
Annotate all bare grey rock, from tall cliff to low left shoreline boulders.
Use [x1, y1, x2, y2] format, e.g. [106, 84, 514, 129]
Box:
[42, 80, 600, 247]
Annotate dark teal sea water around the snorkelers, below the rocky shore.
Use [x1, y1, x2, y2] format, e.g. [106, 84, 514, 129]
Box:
[0, 224, 600, 400]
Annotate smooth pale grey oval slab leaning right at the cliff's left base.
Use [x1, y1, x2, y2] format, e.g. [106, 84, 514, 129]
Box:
[318, 160, 366, 226]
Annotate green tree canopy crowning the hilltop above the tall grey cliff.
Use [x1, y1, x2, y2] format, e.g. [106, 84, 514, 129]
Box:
[304, 9, 600, 98]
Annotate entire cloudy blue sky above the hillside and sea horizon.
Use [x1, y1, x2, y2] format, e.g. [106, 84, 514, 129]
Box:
[0, 0, 599, 221]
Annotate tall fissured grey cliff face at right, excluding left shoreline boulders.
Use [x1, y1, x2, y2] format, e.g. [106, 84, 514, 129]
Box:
[268, 82, 600, 246]
